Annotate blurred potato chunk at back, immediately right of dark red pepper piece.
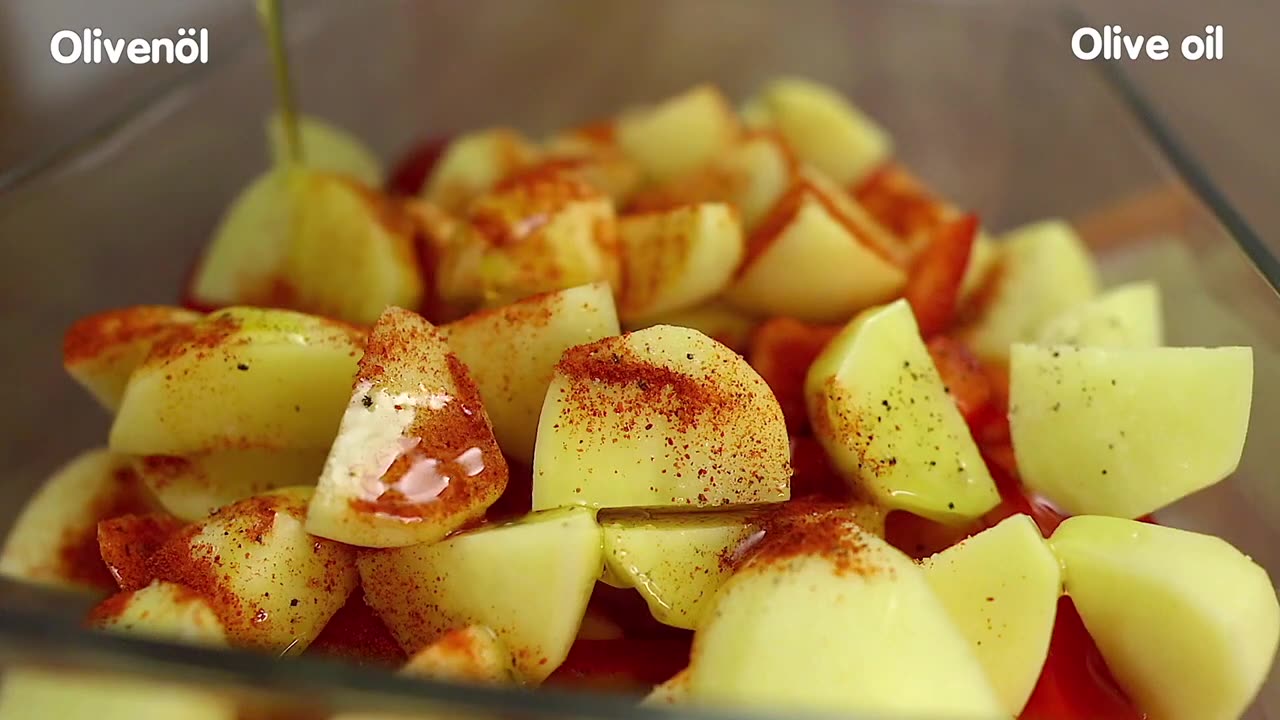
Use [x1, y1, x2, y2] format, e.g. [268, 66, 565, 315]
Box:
[422, 128, 538, 213]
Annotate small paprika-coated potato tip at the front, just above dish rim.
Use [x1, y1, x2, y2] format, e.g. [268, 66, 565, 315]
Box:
[401, 625, 516, 684]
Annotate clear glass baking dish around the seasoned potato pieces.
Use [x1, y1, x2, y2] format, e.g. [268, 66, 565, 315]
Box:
[0, 0, 1280, 719]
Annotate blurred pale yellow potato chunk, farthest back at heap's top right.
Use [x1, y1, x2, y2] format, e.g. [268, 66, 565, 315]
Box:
[742, 77, 893, 186]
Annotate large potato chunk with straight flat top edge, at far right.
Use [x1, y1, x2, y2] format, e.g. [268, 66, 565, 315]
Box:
[1009, 345, 1253, 518]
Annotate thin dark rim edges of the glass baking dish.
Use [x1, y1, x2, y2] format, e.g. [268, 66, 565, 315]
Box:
[0, 0, 1280, 720]
